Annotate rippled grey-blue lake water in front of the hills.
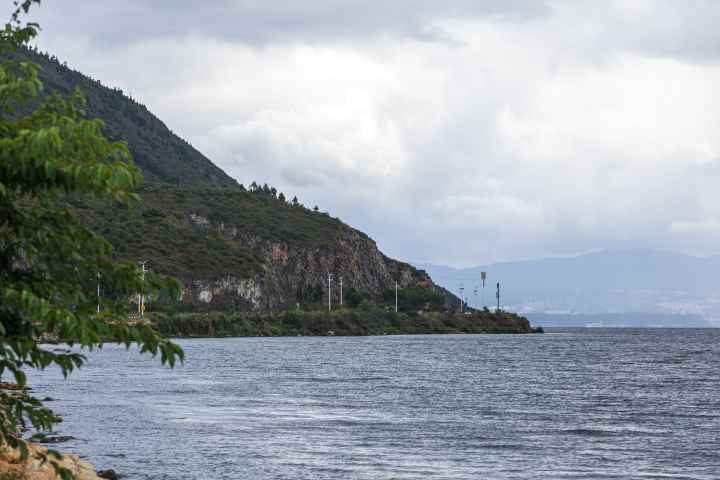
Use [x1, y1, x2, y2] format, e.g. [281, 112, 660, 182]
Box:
[23, 329, 720, 479]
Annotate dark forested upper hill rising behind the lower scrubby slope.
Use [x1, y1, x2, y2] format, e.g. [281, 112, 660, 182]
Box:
[2, 48, 239, 188]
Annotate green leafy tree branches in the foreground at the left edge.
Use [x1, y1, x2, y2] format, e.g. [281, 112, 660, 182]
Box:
[0, 0, 183, 479]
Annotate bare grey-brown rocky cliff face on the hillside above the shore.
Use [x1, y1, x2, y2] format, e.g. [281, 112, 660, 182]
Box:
[150, 214, 433, 310]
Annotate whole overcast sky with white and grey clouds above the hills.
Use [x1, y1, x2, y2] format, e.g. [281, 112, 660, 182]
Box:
[14, 0, 720, 267]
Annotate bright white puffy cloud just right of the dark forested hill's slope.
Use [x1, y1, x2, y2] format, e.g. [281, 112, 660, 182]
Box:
[197, 91, 407, 184]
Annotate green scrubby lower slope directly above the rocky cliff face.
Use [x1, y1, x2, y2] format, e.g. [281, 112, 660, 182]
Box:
[65, 183, 358, 277]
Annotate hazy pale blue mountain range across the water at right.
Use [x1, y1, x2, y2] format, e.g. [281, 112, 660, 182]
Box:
[412, 249, 720, 320]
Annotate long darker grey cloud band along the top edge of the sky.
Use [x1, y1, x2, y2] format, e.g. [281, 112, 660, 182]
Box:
[31, 0, 550, 46]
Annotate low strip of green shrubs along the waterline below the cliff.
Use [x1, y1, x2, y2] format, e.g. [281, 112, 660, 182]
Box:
[146, 309, 543, 337]
